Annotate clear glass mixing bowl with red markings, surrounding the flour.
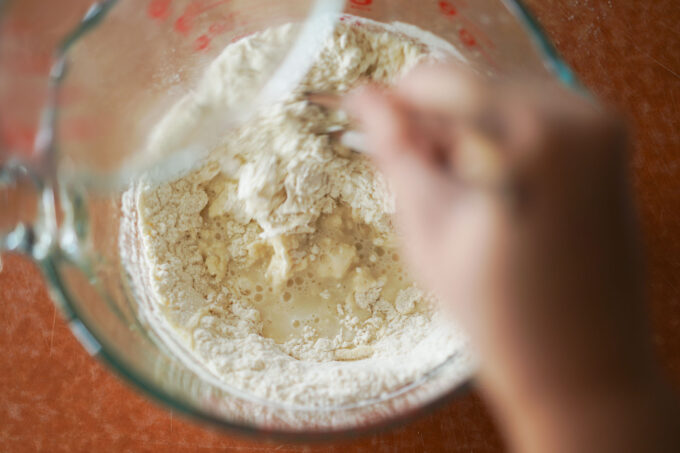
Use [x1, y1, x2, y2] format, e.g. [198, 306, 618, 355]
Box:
[0, 0, 577, 439]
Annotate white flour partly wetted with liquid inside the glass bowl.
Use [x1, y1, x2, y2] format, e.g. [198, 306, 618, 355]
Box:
[125, 17, 469, 407]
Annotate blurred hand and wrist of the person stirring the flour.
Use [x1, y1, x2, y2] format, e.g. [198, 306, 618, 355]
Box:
[346, 65, 676, 451]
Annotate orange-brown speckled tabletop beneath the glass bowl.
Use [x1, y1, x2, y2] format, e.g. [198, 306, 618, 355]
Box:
[0, 0, 680, 453]
